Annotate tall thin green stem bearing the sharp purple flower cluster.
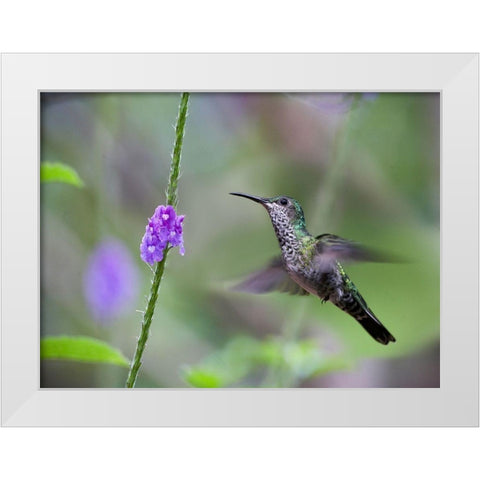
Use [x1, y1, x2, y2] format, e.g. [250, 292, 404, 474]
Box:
[125, 93, 190, 388]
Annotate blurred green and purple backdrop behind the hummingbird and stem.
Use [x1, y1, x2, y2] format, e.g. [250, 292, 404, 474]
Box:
[41, 93, 440, 388]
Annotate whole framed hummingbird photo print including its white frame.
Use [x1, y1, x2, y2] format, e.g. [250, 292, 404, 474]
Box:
[2, 54, 478, 426]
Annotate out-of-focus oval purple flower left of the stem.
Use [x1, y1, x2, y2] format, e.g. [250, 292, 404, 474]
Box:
[83, 239, 138, 324]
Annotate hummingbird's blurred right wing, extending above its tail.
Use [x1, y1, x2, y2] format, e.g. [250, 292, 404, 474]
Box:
[314, 233, 397, 270]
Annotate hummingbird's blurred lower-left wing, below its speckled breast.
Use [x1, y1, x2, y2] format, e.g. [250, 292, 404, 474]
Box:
[233, 257, 308, 295]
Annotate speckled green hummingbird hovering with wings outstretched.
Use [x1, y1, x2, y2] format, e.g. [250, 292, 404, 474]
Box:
[230, 192, 395, 345]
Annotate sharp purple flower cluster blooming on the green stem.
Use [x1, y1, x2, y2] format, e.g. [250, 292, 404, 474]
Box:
[140, 205, 185, 265]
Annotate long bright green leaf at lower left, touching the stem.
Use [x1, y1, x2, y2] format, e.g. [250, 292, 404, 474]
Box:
[40, 336, 130, 367]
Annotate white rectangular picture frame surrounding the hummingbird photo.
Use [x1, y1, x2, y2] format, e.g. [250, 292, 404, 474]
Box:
[2, 54, 479, 426]
